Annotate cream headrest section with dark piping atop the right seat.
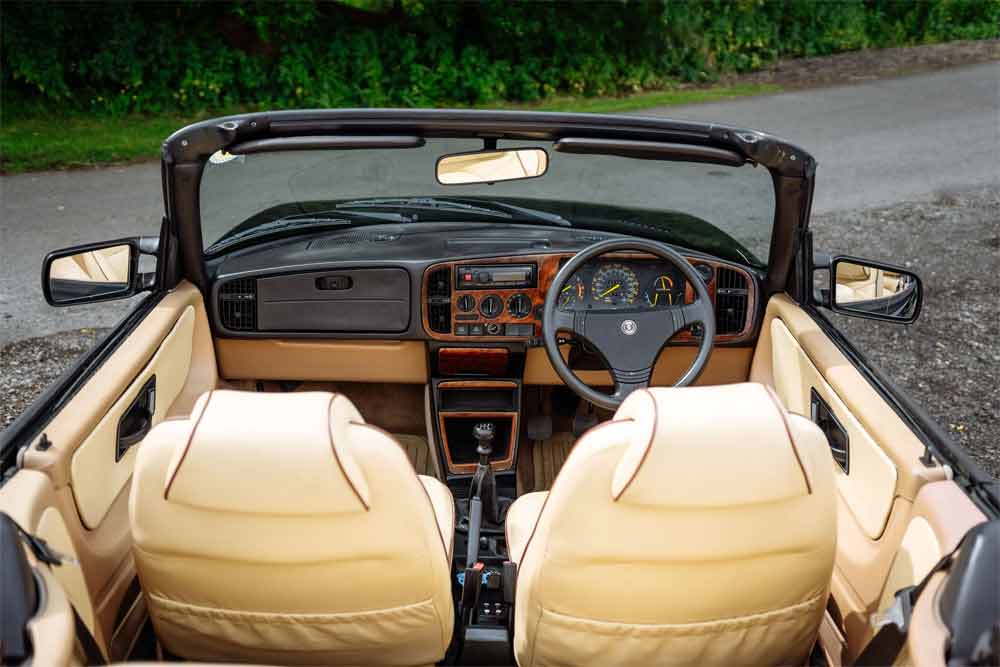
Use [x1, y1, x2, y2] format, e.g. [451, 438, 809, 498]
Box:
[611, 383, 811, 508]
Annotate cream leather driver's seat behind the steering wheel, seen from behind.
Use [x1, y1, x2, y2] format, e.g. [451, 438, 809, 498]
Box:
[507, 384, 836, 667]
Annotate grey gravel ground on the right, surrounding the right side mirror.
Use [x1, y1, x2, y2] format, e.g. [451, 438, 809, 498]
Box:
[811, 187, 1000, 477]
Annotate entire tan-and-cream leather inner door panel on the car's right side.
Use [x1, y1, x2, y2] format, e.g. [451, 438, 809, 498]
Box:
[750, 294, 982, 664]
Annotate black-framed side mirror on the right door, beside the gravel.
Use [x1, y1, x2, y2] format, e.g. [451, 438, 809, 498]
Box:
[829, 256, 923, 324]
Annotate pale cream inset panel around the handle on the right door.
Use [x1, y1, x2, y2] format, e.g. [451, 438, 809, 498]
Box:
[770, 318, 897, 539]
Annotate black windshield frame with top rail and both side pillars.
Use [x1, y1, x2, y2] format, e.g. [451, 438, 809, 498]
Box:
[162, 109, 816, 293]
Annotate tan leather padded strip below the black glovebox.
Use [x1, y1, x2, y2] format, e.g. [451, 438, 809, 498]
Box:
[215, 338, 427, 384]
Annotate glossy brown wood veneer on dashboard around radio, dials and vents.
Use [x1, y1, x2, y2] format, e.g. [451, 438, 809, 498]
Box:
[420, 252, 757, 343]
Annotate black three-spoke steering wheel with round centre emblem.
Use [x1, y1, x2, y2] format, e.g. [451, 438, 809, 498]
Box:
[542, 239, 715, 410]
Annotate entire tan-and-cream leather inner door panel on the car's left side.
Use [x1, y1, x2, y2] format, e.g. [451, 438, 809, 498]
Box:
[0, 282, 218, 659]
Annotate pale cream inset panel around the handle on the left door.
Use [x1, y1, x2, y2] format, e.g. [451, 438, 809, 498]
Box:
[70, 306, 195, 529]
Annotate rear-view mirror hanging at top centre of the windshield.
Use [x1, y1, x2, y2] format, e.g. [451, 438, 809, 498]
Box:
[437, 148, 549, 185]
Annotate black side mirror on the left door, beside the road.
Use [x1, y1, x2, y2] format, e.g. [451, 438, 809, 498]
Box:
[42, 237, 159, 306]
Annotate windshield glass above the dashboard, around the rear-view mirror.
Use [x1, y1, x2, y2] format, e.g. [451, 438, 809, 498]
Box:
[200, 139, 775, 265]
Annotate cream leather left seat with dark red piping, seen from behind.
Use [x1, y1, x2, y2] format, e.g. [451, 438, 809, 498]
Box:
[129, 391, 455, 665]
